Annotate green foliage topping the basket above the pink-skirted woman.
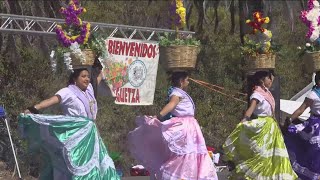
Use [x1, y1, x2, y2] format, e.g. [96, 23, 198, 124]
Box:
[159, 33, 200, 47]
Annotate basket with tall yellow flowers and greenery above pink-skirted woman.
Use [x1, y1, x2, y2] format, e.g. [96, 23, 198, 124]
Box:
[159, 0, 200, 71]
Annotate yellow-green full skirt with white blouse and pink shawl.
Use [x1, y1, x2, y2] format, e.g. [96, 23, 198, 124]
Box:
[223, 87, 297, 180]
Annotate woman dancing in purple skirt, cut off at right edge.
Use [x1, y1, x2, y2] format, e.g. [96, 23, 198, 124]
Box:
[284, 71, 320, 180]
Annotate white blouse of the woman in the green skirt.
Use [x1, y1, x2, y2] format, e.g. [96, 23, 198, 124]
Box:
[56, 83, 97, 119]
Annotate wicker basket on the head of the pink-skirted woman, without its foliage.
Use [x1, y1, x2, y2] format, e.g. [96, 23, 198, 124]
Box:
[160, 46, 199, 71]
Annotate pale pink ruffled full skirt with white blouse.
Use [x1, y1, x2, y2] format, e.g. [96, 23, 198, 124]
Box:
[128, 88, 218, 180]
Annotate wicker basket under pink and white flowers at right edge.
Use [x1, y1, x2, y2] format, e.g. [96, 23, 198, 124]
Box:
[304, 51, 320, 73]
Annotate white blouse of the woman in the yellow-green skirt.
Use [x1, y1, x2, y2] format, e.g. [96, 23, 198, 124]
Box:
[250, 92, 272, 116]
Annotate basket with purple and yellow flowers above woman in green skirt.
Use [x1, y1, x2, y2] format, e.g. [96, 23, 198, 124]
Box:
[55, 0, 104, 70]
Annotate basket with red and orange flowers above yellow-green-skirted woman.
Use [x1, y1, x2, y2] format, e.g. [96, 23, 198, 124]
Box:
[241, 11, 279, 70]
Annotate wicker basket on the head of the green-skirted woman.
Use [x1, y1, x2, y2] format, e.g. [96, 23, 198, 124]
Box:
[70, 49, 96, 66]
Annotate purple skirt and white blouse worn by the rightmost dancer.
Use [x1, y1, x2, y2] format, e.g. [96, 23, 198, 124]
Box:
[284, 88, 320, 180]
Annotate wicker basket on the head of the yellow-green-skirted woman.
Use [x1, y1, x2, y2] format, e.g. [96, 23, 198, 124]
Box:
[245, 54, 276, 71]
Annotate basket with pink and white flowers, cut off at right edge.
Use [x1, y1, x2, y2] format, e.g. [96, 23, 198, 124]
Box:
[300, 0, 320, 72]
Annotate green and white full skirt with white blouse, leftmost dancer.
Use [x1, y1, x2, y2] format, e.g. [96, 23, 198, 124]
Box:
[19, 84, 120, 180]
